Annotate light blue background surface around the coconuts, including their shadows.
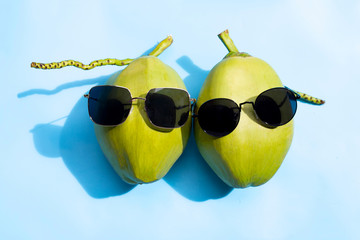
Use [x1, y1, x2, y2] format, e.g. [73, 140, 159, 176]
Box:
[0, 0, 360, 240]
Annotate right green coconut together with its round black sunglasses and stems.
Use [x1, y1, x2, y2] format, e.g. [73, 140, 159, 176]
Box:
[194, 30, 324, 188]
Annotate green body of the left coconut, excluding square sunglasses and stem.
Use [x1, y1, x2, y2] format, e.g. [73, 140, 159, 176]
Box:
[95, 56, 191, 184]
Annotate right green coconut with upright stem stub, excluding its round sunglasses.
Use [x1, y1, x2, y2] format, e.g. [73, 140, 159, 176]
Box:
[194, 31, 294, 188]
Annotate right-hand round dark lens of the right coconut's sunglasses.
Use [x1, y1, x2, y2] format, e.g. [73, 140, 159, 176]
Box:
[255, 88, 297, 126]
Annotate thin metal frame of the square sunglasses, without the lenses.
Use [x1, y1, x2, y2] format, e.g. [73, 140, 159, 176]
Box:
[84, 85, 196, 129]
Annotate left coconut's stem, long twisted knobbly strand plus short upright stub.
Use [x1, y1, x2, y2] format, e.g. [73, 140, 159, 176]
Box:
[31, 36, 173, 70]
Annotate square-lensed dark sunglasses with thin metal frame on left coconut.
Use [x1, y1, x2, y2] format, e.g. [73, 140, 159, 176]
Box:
[84, 85, 193, 129]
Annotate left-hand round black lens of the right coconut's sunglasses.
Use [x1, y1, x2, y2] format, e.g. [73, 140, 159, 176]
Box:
[198, 98, 240, 137]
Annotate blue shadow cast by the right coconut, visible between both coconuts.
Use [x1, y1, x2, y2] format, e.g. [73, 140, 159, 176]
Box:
[164, 56, 233, 201]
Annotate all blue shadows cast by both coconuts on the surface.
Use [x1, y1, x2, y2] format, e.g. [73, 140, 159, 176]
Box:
[18, 56, 232, 201]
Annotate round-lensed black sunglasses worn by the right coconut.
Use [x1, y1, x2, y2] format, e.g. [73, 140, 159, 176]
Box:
[195, 87, 300, 137]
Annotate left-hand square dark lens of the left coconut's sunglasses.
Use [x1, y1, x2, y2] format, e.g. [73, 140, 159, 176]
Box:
[88, 86, 131, 126]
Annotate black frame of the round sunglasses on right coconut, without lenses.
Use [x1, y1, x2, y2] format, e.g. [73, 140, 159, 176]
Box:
[193, 86, 301, 137]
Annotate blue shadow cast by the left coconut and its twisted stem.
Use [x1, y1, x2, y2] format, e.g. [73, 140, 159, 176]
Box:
[28, 76, 135, 198]
